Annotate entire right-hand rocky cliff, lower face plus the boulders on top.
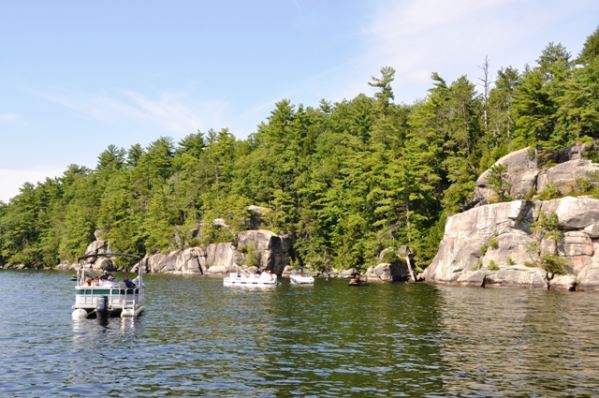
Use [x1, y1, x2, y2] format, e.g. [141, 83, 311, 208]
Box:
[423, 148, 599, 289]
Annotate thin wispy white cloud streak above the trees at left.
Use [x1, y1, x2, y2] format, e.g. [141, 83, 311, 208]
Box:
[33, 90, 228, 136]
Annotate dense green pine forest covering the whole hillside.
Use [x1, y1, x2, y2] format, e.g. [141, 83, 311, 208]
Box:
[0, 29, 599, 268]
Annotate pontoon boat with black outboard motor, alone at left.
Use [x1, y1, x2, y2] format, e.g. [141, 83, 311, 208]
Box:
[72, 254, 145, 319]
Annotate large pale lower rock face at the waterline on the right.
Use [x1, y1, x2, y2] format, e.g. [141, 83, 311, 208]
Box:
[424, 197, 599, 289]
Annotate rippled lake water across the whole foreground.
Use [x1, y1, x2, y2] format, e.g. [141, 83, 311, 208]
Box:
[0, 271, 599, 397]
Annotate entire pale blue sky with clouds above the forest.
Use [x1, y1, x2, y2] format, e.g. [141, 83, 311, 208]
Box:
[0, 0, 599, 203]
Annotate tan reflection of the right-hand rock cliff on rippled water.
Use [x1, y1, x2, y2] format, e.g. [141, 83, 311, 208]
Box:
[439, 287, 599, 396]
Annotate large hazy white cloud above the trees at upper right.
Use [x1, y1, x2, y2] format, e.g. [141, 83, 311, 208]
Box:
[288, 0, 596, 103]
